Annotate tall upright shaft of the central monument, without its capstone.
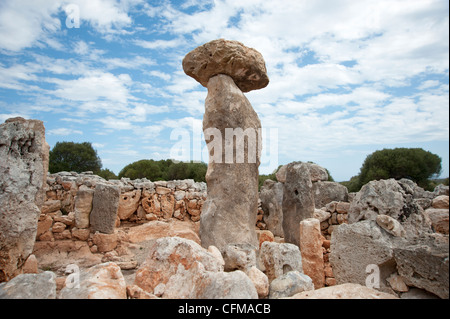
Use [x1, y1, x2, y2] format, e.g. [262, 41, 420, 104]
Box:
[200, 74, 261, 250]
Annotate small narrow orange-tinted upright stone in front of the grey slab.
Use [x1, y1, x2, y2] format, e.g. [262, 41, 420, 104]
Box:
[300, 218, 325, 289]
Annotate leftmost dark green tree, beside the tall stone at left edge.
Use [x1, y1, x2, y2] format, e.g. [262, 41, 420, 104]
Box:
[49, 142, 102, 173]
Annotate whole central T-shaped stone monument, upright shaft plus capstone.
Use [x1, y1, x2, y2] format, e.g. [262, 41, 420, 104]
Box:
[183, 39, 269, 251]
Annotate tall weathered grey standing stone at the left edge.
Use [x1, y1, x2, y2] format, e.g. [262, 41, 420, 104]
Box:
[0, 118, 49, 282]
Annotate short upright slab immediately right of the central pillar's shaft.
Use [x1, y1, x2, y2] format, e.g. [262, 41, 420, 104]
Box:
[259, 179, 284, 237]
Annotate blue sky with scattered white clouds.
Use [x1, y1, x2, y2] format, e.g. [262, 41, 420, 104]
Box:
[0, 0, 449, 181]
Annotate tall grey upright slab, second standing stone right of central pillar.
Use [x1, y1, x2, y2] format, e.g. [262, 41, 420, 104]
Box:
[282, 162, 315, 246]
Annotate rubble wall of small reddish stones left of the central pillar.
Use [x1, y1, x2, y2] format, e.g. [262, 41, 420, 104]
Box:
[36, 172, 206, 246]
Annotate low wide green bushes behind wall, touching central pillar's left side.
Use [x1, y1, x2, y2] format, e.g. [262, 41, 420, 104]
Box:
[119, 159, 208, 182]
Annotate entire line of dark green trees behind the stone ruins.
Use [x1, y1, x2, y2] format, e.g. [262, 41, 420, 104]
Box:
[49, 142, 449, 192]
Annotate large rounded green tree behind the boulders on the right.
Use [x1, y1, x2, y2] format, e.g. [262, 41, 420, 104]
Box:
[358, 148, 442, 189]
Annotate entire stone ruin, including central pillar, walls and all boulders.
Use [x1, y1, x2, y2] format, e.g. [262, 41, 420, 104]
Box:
[0, 39, 449, 299]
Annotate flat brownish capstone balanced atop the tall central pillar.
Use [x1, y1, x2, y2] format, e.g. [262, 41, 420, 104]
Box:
[183, 39, 269, 92]
